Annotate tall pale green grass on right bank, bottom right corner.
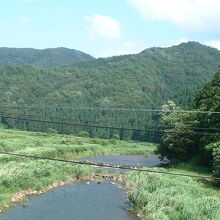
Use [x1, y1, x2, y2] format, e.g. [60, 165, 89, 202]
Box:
[125, 172, 220, 220]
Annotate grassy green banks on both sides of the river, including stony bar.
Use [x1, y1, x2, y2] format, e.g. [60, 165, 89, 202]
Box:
[0, 130, 220, 220]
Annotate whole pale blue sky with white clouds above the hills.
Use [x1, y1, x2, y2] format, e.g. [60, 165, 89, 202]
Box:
[0, 0, 220, 57]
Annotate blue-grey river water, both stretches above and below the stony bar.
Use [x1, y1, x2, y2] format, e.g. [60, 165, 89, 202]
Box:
[0, 155, 161, 220]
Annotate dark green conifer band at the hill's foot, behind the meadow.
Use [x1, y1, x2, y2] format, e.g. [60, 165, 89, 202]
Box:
[0, 106, 161, 142]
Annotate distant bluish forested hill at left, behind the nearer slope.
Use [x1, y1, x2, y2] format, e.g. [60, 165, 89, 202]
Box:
[0, 47, 93, 68]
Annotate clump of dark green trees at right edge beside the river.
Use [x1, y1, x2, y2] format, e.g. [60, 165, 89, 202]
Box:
[157, 71, 220, 176]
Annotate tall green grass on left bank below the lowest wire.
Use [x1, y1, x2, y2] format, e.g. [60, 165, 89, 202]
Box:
[0, 160, 92, 208]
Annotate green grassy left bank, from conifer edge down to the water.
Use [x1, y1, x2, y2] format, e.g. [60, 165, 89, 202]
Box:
[0, 129, 154, 210]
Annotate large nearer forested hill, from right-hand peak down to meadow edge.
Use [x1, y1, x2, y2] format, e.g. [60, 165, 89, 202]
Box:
[0, 42, 220, 141]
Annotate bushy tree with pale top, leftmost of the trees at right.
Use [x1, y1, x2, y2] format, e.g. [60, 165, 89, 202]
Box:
[157, 101, 198, 161]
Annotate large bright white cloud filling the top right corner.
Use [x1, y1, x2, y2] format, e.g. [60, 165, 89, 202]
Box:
[127, 0, 220, 31]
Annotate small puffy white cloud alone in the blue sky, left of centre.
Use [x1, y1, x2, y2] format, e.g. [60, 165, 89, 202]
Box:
[86, 14, 122, 40]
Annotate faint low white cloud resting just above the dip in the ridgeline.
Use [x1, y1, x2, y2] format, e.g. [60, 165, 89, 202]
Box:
[98, 41, 146, 57]
